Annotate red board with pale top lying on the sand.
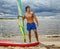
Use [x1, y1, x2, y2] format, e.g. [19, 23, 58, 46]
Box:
[0, 40, 40, 47]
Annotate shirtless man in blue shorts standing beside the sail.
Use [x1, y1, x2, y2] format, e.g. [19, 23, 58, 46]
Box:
[23, 6, 39, 42]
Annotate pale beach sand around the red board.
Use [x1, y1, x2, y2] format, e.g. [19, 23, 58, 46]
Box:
[0, 35, 60, 49]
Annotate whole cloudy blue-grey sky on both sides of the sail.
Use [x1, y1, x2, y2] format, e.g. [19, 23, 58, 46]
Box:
[0, 0, 60, 18]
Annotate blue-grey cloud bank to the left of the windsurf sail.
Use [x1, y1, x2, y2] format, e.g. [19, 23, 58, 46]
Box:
[0, 0, 17, 15]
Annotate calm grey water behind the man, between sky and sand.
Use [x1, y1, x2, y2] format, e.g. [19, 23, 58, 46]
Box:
[0, 17, 60, 35]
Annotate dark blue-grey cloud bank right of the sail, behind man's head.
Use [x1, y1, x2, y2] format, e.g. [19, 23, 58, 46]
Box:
[22, 0, 60, 13]
